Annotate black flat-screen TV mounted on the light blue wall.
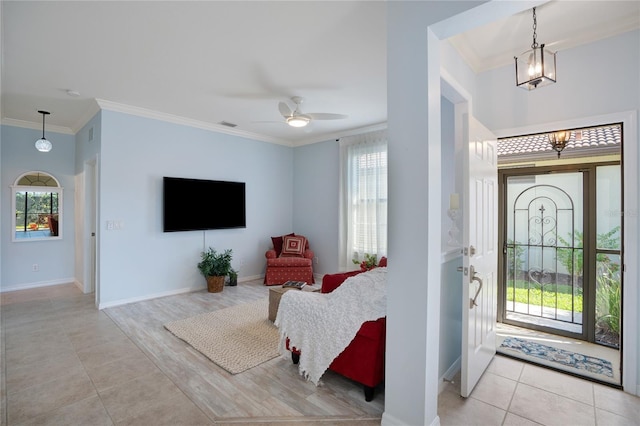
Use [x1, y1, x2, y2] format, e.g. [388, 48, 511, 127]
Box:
[163, 176, 247, 232]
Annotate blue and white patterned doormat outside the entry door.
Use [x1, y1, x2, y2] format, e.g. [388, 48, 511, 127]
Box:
[500, 337, 613, 378]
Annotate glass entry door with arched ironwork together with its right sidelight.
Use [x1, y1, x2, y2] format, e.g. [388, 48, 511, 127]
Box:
[499, 164, 622, 348]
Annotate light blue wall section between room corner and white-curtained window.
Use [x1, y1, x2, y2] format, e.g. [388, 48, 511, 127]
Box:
[293, 140, 340, 275]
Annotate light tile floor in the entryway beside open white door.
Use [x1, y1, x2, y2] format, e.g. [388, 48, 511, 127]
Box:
[438, 355, 640, 426]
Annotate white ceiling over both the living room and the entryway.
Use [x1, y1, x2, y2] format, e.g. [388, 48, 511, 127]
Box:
[0, 1, 640, 145]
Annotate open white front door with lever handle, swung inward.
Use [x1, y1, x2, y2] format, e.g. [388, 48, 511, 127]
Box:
[460, 116, 498, 398]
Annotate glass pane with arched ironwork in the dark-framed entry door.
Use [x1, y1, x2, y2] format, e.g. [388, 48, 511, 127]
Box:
[505, 172, 584, 334]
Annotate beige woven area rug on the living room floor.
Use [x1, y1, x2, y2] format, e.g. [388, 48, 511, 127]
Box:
[164, 298, 280, 374]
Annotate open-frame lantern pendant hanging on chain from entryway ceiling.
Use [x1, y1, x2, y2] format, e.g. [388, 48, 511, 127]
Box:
[514, 7, 556, 90]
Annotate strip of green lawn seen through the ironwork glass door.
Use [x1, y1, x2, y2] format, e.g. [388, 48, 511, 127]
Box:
[507, 281, 582, 312]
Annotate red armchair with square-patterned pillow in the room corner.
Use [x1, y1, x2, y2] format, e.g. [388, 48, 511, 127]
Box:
[264, 234, 315, 285]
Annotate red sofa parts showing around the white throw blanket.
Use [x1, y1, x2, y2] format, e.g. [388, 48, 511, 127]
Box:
[287, 257, 387, 401]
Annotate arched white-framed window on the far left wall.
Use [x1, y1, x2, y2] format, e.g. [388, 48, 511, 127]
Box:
[11, 171, 62, 242]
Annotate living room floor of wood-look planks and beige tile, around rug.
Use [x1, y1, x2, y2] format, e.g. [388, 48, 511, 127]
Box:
[0, 281, 384, 426]
